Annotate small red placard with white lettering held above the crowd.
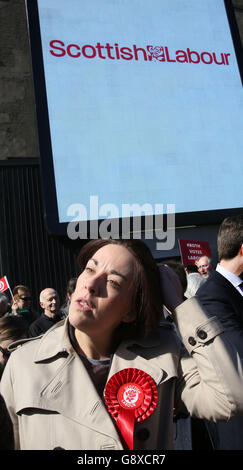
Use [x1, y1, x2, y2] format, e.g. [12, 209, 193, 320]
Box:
[178, 239, 212, 266]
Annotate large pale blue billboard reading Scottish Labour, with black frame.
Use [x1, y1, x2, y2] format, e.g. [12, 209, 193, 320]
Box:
[27, 0, 243, 237]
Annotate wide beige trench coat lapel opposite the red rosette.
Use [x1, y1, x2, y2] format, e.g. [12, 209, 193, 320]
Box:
[30, 320, 120, 442]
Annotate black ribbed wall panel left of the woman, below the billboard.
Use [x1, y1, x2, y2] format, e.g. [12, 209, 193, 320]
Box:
[0, 158, 82, 310]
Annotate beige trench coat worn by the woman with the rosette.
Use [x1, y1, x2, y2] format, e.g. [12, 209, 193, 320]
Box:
[1, 299, 243, 450]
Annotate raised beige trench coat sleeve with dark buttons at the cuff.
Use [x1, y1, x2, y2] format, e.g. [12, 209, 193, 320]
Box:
[174, 297, 243, 421]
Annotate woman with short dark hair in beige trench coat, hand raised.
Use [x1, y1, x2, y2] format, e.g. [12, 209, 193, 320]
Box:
[1, 240, 243, 451]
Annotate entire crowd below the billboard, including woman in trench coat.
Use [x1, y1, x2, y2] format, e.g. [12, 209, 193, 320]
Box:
[0, 216, 243, 450]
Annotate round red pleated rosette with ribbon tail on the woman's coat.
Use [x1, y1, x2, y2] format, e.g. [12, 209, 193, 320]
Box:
[104, 368, 158, 450]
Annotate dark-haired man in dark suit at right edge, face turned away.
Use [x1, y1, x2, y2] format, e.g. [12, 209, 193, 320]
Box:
[196, 215, 243, 450]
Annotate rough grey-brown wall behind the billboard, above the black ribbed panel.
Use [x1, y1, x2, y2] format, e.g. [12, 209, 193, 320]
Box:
[0, 0, 243, 159]
